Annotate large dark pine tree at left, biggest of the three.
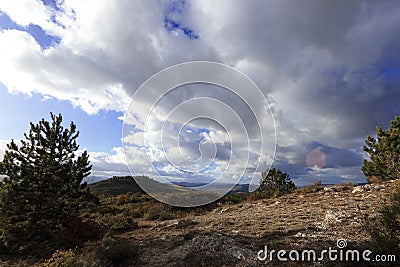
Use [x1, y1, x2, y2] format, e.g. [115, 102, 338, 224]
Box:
[0, 113, 94, 255]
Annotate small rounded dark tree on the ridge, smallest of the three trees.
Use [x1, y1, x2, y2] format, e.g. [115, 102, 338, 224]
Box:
[258, 168, 296, 198]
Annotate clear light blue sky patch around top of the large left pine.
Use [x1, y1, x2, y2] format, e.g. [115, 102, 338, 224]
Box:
[0, 83, 123, 154]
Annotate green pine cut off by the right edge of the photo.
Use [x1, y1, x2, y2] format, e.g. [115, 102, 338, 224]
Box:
[362, 116, 400, 181]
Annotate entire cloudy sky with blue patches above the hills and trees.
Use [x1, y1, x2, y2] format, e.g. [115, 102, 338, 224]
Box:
[0, 0, 400, 185]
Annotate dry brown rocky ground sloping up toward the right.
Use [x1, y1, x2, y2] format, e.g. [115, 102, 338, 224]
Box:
[124, 182, 398, 266]
